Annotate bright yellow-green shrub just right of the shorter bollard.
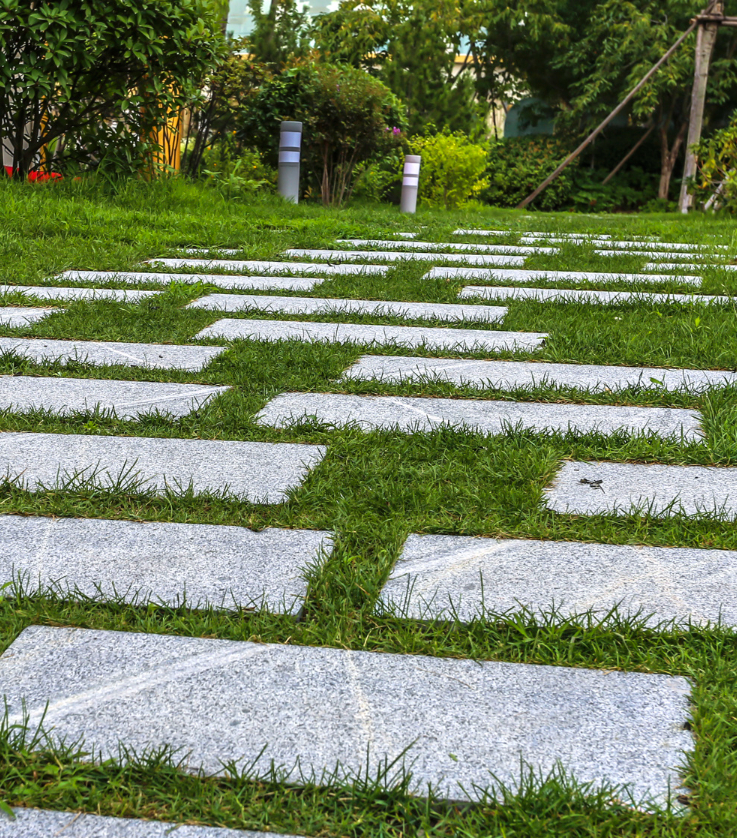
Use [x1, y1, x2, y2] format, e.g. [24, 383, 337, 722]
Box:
[409, 131, 489, 209]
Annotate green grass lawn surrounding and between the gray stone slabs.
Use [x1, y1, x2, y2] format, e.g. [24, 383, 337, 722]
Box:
[0, 177, 737, 838]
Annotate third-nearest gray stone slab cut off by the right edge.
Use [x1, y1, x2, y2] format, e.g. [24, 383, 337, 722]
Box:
[343, 355, 737, 393]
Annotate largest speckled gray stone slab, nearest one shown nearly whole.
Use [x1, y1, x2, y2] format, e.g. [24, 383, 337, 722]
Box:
[0, 626, 693, 805]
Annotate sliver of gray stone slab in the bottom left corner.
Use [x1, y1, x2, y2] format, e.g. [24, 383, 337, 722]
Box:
[0, 808, 297, 838]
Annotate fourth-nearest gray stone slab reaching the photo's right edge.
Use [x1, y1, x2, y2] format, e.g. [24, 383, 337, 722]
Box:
[458, 285, 732, 305]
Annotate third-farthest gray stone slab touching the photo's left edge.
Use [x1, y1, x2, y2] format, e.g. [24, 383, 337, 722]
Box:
[0, 337, 225, 372]
